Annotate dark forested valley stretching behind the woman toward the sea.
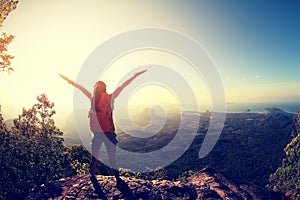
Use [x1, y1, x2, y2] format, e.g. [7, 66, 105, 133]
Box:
[114, 108, 295, 185]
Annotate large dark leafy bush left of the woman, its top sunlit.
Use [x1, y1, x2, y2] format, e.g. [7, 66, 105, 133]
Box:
[0, 94, 71, 199]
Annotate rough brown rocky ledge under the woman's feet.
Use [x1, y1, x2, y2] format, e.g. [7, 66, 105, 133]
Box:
[26, 168, 282, 200]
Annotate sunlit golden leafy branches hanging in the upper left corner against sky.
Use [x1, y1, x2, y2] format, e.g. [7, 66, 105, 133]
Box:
[0, 0, 19, 73]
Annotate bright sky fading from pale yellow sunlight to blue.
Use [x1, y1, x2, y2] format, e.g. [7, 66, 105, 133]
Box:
[0, 0, 300, 127]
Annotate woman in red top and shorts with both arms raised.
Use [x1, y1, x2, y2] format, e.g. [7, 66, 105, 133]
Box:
[60, 70, 147, 183]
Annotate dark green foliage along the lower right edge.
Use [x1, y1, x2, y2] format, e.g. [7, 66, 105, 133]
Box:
[268, 110, 300, 199]
